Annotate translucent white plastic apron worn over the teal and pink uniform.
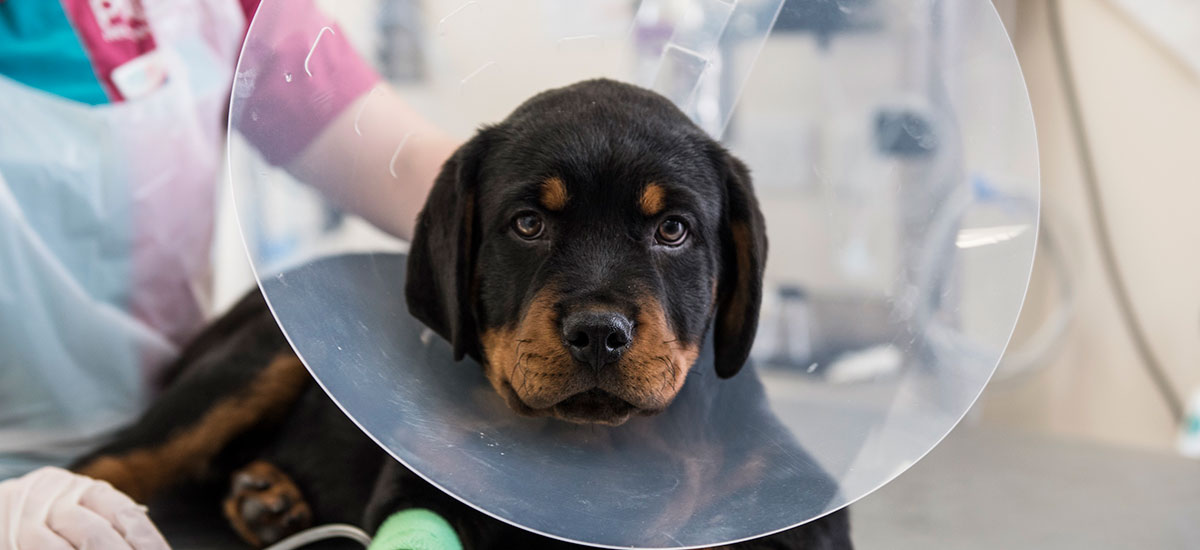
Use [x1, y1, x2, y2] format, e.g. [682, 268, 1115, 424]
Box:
[0, 0, 245, 478]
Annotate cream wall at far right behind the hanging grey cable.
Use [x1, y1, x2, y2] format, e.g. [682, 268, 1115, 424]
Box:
[978, 0, 1200, 450]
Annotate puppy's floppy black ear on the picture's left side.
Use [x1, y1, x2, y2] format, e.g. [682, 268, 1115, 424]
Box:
[404, 128, 491, 360]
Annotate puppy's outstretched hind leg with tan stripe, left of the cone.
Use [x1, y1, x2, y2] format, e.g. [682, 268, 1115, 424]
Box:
[73, 289, 311, 502]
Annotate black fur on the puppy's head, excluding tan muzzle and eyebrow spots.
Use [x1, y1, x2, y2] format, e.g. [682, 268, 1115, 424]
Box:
[407, 80, 767, 377]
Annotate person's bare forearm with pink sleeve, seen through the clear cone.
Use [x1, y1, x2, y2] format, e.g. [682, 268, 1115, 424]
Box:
[232, 2, 457, 239]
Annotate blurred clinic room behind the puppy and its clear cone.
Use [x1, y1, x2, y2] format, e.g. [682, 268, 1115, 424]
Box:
[196, 0, 1200, 548]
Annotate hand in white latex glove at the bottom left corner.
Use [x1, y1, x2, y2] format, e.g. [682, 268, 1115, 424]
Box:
[0, 467, 170, 550]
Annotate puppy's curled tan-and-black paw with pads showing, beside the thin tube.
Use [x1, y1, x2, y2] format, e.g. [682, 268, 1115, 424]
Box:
[222, 460, 312, 546]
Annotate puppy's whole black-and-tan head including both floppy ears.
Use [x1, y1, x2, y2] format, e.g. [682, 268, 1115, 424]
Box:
[406, 80, 767, 425]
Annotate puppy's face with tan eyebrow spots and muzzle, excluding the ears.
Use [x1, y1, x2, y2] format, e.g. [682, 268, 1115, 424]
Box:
[475, 122, 722, 424]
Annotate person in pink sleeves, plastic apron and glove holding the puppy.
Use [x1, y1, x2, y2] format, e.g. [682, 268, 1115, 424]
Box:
[0, 0, 457, 542]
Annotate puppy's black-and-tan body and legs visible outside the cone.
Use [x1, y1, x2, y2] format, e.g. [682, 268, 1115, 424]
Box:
[76, 291, 851, 550]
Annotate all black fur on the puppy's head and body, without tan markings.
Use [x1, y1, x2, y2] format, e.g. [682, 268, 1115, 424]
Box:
[72, 80, 851, 550]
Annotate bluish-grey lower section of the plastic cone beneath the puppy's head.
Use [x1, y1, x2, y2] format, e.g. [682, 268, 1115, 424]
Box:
[263, 255, 841, 546]
